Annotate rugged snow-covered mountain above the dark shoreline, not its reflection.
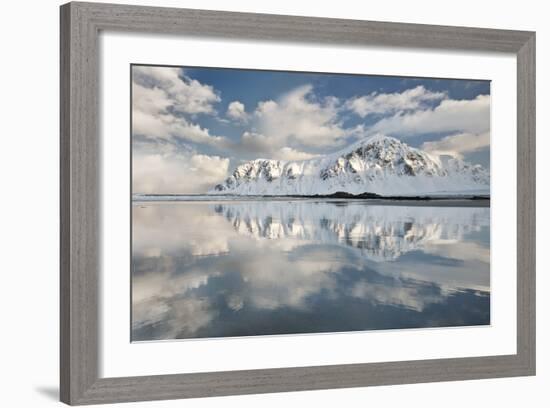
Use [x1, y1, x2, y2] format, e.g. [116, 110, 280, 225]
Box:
[209, 135, 490, 196]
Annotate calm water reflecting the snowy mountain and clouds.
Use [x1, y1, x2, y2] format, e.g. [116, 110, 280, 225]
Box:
[132, 200, 490, 341]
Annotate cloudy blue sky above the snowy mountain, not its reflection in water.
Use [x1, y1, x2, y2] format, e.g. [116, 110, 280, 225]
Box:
[132, 65, 490, 193]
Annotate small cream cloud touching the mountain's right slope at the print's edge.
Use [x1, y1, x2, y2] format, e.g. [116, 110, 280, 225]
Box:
[421, 132, 490, 158]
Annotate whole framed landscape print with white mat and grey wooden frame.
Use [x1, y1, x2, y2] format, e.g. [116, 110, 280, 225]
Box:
[60, 3, 535, 405]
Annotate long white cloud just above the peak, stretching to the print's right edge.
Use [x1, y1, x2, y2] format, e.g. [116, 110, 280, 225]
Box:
[371, 95, 490, 136]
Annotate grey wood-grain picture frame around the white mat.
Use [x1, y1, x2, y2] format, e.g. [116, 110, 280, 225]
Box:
[60, 2, 535, 405]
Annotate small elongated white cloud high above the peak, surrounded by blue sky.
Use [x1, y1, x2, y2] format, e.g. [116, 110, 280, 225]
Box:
[346, 86, 446, 118]
